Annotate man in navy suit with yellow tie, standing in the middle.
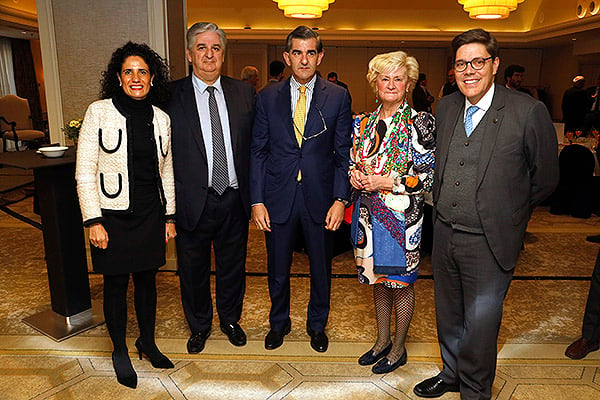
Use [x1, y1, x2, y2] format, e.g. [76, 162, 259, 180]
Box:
[250, 26, 351, 352]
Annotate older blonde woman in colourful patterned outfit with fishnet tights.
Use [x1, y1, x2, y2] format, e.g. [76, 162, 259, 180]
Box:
[349, 51, 435, 374]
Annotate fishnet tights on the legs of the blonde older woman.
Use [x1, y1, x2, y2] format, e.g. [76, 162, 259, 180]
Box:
[373, 283, 415, 363]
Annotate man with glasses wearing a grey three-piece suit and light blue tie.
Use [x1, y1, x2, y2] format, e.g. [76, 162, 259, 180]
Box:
[414, 29, 559, 400]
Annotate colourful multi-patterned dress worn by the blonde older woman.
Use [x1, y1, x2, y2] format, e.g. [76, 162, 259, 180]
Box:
[349, 103, 435, 288]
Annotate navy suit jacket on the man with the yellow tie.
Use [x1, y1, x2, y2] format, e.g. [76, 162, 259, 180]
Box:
[251, 77, 352, 223]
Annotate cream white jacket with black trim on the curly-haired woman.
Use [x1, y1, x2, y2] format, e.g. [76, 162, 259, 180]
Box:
[75, 99, 175, 226]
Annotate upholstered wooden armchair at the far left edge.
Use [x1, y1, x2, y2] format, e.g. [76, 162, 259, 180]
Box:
[0, 94, 49, 151]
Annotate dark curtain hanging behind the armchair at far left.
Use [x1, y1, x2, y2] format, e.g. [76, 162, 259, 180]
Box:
[10, 39, 43, 130]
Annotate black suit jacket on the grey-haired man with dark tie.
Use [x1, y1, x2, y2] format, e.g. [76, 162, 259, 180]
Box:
[167, 75, 254, 230]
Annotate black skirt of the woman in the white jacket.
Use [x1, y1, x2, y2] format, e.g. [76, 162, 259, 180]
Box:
[91, 185, 166, 275]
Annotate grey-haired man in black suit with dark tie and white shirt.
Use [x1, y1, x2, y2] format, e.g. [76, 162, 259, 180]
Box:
[168, 22, 254, 353]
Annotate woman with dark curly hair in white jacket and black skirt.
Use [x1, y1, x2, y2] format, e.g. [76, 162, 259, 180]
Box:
[76, 42, 176, 388]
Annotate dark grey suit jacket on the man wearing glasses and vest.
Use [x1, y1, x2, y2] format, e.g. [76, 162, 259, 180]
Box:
[433, 85, 559, 270]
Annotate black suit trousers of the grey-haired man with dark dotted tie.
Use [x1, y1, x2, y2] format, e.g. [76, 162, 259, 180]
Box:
[176, 189, 249, 334]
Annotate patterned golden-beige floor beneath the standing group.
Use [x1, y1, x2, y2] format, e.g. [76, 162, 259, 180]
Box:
[0, 192, 600, 400]
